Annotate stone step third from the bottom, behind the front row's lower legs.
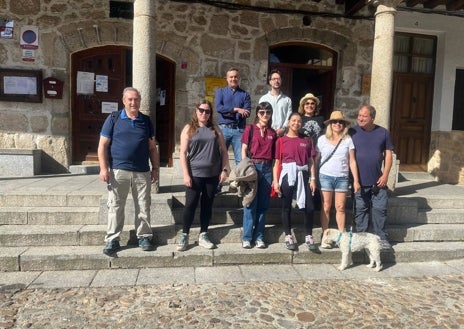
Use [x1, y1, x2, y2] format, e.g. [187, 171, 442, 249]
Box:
[0, 200, 464, 225]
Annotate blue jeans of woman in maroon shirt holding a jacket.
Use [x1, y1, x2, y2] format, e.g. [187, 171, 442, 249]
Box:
[242, 164, 272, 242]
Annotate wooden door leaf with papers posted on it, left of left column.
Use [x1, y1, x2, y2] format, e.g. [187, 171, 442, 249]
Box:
[71, 46, 132, 164]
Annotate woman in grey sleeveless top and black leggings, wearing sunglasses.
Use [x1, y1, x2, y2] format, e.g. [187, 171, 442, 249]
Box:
[177, 99, 230, 251]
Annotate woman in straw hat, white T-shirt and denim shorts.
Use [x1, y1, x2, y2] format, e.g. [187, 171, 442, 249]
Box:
[316, 111, 361, 249]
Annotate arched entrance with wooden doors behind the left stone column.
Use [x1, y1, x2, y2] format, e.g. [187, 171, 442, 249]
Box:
[71, 46, 176, 166]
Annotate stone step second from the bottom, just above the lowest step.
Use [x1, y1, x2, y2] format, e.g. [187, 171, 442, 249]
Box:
[0, 223, 464, 247]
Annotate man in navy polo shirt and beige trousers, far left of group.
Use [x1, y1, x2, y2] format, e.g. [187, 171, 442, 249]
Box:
[98, 87, 159, 255]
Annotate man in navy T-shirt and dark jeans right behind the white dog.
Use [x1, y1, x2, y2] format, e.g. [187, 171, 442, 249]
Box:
[349, 105, 393, 249]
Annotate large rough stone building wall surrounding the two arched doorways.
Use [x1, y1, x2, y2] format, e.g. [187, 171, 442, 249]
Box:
[0, 0, 374, 172]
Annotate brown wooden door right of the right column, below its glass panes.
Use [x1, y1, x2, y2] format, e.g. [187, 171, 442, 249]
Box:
[390, 74, 433, 168]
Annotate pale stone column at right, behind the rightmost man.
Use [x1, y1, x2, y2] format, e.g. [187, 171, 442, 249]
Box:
[370, 0, 400, 129]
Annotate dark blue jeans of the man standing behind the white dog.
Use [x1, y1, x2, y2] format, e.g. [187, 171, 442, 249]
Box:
[354, 187, 388, 239]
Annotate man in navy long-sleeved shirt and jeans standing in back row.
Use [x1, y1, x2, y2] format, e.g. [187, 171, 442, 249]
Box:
[214, 68, 251, 164]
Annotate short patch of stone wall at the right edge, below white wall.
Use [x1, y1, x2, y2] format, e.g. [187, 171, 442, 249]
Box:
[427, 131, 464, 184]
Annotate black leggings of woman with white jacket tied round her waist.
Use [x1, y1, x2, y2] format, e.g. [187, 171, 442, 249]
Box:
[280, 171, 314, 235]
